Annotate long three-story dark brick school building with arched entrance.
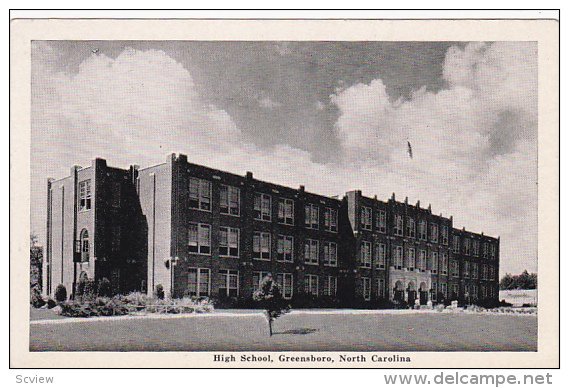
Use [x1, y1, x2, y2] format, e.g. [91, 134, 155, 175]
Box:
[43, 154, 499, 306]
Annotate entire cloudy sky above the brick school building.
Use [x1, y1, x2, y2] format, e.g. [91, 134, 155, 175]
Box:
[31, 41, 537, 274]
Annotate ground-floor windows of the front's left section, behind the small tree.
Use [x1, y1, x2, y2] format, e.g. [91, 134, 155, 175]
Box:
[187, 268, 338, 299]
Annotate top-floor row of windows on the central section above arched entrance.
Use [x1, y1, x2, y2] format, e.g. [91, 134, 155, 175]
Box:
[360, 206, 449, 245]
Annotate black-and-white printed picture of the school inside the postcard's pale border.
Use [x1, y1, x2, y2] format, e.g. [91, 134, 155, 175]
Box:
[12, 13, 558, 367]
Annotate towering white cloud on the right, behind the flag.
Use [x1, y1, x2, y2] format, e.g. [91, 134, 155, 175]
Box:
[331, 42, 537, 270]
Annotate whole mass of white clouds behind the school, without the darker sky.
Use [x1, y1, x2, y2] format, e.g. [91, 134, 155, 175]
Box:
[31, 42, 537, 271]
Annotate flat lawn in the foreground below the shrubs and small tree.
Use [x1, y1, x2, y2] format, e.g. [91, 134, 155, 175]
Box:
[30, 310, 537, 351]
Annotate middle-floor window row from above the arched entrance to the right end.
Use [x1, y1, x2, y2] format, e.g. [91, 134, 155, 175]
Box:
[359, 241, 495, 280]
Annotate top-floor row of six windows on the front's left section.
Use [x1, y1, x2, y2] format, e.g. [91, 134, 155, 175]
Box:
[189, 178, 338, 232]
